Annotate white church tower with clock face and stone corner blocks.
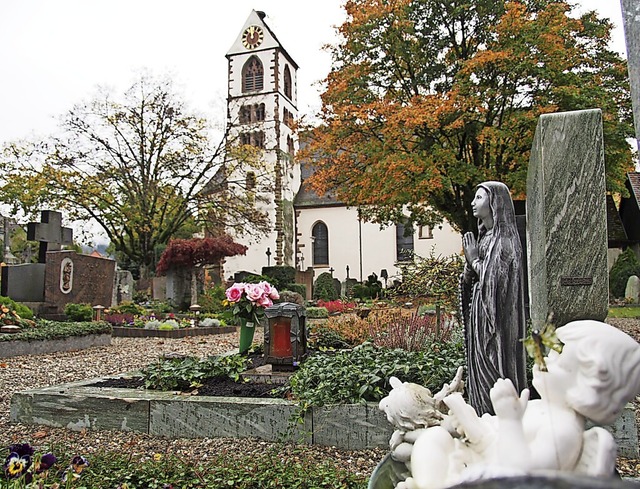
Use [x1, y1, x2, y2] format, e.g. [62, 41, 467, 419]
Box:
[225, 10, 300, 276]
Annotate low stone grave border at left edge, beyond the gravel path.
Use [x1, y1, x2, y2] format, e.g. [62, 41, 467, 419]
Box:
[0, 333, 111, 358]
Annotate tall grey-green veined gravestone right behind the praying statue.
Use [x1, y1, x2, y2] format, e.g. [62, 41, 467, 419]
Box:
[527, 109, 609, 329]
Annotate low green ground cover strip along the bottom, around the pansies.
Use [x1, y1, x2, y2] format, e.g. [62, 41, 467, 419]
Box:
[0, 445, 368, 489]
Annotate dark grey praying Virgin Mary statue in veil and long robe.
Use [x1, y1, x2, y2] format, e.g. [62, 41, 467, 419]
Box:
[460, 182, 526, 415]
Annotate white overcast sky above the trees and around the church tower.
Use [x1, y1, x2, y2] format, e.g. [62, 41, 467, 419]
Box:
[0, 0, 624, 145]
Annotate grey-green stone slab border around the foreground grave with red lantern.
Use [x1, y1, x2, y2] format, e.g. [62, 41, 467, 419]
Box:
[11, 373, 638, 458]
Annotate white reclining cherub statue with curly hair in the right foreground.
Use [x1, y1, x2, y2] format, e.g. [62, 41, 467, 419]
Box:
[378, 320, 640, 489]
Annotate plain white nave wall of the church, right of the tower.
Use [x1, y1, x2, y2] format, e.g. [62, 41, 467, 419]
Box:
[297, 207, 462, 283]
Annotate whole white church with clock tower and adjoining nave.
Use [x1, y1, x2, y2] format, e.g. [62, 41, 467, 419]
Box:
[224, 10, 462, 281]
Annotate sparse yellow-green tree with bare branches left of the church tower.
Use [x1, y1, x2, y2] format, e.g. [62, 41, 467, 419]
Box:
[0, 76, 271, 276]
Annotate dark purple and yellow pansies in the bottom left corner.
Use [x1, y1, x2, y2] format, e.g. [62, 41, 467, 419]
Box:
[0, 443, 89, 488]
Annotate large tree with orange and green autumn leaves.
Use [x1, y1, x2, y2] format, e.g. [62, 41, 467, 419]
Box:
[301, 0, 633, 231]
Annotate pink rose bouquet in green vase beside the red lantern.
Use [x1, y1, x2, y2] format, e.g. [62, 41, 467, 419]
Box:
[225, 281, 280, 323]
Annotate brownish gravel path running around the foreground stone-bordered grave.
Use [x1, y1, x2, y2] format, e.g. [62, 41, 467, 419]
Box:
[0, 319, 640, 477]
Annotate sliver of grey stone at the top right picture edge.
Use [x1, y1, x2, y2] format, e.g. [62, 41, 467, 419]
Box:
[620, 0, 640, 152]
